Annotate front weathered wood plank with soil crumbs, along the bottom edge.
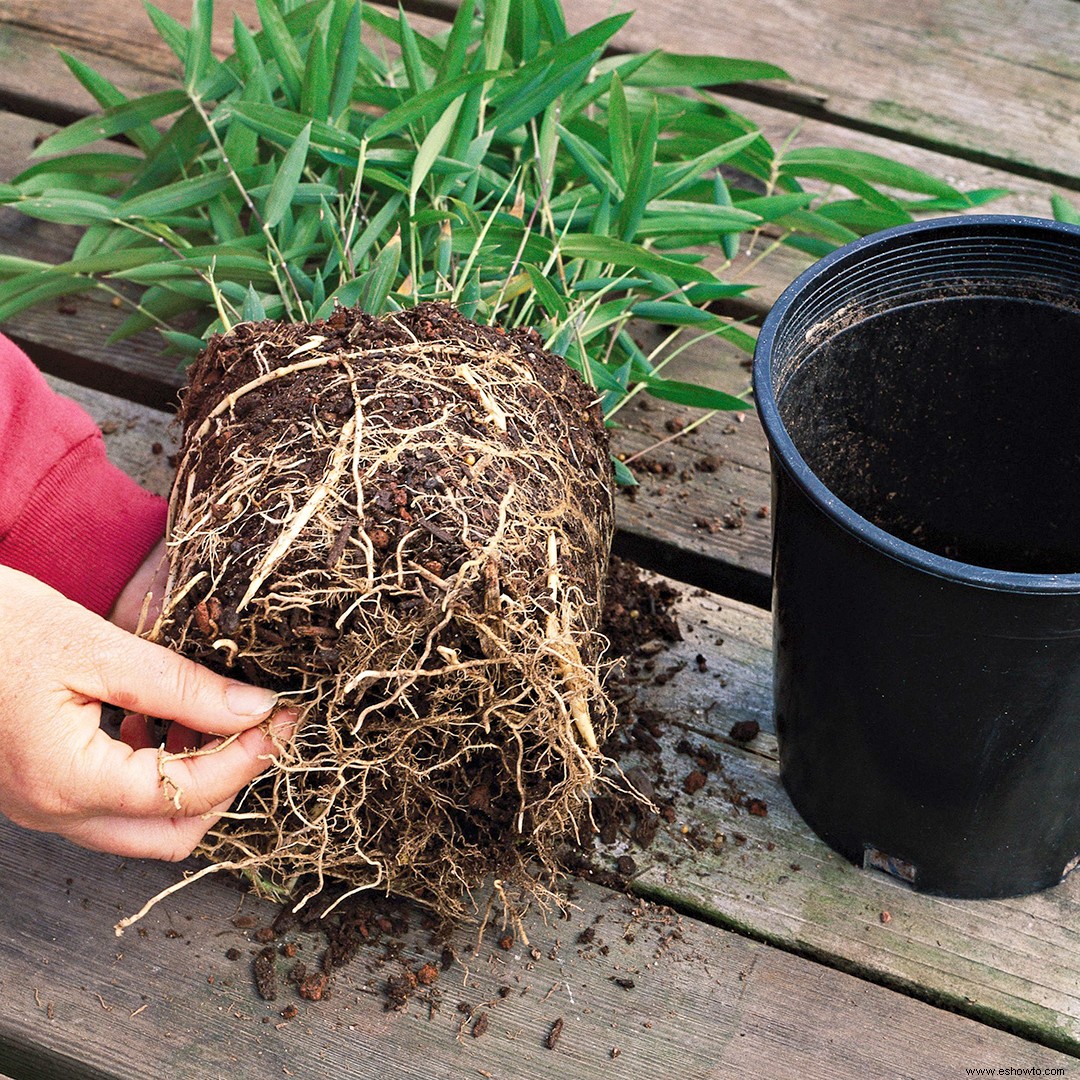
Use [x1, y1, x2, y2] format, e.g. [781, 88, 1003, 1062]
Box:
[0, 822, 1067, 1080]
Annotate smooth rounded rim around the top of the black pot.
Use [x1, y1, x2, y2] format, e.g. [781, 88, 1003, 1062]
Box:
[753, 214, 1080, 594]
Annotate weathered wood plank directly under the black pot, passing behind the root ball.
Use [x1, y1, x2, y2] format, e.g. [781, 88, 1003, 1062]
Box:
[42, 382, 1080, 1054]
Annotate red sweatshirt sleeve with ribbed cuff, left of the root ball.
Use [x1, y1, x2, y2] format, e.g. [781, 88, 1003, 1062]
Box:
[0, 335, 166, 615]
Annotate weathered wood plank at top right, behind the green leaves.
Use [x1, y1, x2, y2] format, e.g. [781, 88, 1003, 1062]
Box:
[566, 0, 1080, 188]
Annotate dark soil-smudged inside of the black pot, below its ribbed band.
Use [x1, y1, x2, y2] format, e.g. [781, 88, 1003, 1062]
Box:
[780, 296, 1080, 573]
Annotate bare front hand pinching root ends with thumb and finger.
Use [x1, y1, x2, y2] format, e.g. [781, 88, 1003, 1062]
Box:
[0, 567, 295, 860]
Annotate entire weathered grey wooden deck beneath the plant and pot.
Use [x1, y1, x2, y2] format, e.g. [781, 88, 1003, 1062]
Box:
[0, 0, 1080, 1080]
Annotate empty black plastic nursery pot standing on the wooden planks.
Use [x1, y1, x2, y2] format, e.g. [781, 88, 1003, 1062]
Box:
[754, 216, 1080, 896]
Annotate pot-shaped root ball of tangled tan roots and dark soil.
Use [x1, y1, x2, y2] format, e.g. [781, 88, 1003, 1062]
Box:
[153, 305, 613, 914]
